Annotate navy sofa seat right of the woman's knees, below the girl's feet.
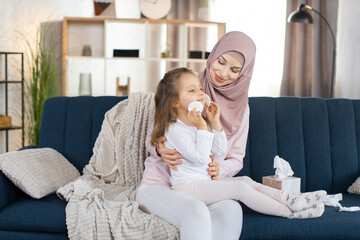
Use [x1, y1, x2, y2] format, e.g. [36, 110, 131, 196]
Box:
[241, 194, 360, 239]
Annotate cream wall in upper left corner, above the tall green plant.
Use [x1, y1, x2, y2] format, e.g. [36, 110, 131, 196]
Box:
[0, 0, 94, 51]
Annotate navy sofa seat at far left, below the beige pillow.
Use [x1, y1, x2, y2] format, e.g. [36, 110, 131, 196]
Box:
[0, 194, 67, 233]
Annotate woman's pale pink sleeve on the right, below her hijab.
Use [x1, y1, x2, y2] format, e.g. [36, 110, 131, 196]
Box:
[219, 105, 250, 177]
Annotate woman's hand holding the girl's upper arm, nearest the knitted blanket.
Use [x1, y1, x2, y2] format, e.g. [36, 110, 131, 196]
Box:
[156, 137, 184, 170]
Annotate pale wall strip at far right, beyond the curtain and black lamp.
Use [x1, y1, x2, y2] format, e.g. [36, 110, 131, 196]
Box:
[335, 0, 360, 99]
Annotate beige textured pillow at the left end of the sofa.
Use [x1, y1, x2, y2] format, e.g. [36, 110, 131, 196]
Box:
[0, 148, 80, 199]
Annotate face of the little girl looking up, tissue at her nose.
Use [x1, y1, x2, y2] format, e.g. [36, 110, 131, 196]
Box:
[175, 73, 205, 113]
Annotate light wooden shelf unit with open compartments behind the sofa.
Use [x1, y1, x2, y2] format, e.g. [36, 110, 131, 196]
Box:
[62, 17, 226, 96]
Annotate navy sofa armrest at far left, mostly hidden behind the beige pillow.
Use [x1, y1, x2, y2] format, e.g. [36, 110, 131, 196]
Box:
[0, 145, 36, 209]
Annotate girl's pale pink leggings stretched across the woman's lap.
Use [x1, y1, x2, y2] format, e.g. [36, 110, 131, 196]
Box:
[172, 176, 291, 216]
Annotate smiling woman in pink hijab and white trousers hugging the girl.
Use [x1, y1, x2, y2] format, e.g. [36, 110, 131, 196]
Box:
[136, 32, 256, 239]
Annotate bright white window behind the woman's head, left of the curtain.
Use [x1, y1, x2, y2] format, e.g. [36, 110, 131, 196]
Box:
[209, 0, 286, 97]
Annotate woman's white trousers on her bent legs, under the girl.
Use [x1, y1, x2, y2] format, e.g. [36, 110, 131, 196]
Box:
[136, 184, 243, 240]
